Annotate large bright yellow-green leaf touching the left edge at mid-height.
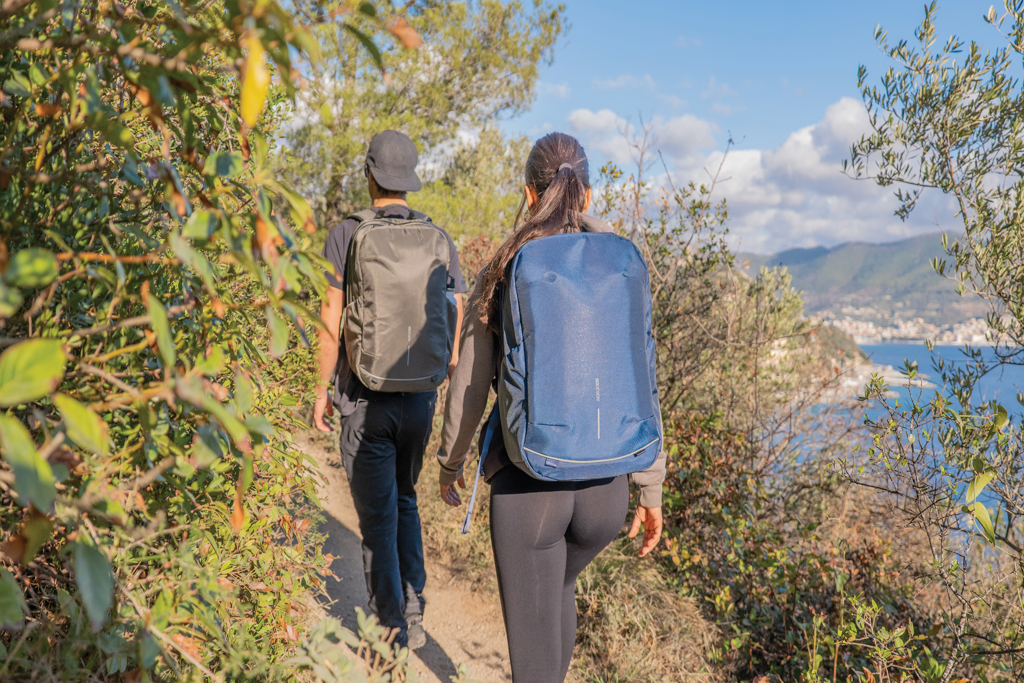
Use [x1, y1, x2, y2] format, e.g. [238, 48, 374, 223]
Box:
[0, 339, 68, 408]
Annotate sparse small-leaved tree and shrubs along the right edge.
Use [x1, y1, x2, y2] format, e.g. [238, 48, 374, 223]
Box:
[839, 0, 1024, 681]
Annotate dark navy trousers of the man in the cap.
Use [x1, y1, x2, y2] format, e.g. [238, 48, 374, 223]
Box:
[341, 387, 437, 645]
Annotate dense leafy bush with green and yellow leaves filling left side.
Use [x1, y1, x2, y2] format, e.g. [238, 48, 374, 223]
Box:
[0, 0, 419, 681]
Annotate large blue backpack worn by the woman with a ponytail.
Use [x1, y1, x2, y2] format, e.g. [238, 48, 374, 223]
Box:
[498, 232, 662, 481]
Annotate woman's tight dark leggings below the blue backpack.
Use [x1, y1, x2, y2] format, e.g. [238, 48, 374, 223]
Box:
[490, 465, 630, 683]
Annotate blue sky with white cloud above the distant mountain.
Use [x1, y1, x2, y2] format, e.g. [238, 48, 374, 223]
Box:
[495, 0, 999, 252]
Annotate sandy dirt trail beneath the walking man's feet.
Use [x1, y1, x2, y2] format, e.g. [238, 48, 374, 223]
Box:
[296, 437, 512, 683]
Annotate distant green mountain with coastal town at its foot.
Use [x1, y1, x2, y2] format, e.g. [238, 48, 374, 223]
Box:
[736, 233, 988, 325]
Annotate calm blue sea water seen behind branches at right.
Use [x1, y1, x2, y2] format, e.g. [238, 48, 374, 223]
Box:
[861, 344, 1024, 417]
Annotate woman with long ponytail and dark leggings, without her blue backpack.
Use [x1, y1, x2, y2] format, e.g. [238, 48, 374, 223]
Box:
[438, 133, 665, 683]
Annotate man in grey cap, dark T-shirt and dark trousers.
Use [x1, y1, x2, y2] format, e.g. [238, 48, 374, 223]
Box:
[313, 130, 467, 649]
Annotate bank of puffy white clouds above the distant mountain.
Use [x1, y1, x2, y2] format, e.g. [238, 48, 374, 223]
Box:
[567, 97, 956, 254]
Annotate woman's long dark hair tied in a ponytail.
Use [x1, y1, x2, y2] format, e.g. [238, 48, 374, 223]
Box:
[479, 133, 590, 332]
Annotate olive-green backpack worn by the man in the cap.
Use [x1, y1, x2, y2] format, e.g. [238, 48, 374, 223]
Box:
[344, 209, 458, 391]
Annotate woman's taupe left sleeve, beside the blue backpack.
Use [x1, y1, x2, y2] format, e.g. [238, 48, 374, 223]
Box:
[437, 268, 495, 486]
